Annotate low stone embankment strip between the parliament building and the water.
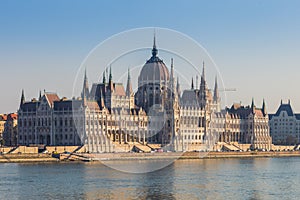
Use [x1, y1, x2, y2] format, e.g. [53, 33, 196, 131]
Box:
[0, 151, 300, 163]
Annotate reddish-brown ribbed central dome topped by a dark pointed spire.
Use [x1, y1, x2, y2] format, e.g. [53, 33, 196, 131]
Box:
[139, 38, 169, 85]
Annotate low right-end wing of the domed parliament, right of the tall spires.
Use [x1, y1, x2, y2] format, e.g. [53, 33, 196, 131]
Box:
[215, 100, 272, 150]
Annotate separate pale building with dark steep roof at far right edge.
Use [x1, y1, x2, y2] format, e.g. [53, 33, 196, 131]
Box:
[269, 101, 300, 145]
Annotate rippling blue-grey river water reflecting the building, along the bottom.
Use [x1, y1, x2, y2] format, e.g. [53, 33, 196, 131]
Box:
[0, 157, 300, 199]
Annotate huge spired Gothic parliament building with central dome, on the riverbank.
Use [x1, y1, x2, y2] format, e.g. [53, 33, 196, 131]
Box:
[17, 38, 271, 153]
